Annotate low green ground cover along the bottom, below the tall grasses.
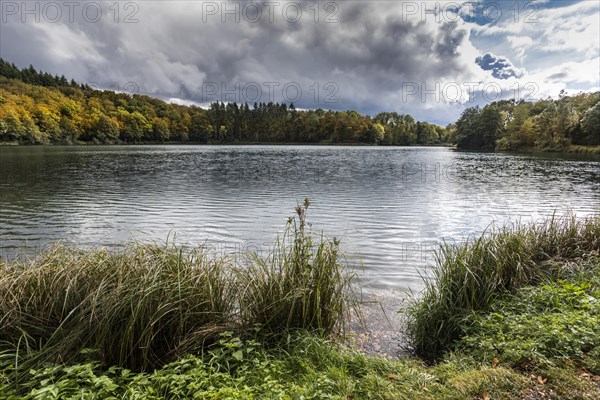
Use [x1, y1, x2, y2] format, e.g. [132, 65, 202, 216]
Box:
[0, 264, 600, 400]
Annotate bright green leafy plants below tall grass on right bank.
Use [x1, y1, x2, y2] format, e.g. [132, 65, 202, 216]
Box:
[456, 272, 600, 374]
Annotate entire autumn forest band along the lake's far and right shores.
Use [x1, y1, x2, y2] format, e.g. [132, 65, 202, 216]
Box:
[0, 58, 600, 153]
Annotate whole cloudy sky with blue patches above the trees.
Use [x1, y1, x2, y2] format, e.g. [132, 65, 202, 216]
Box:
[0, 0, 600, 125]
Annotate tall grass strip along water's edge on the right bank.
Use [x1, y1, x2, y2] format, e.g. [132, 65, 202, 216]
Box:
[407, 215, 600, 358]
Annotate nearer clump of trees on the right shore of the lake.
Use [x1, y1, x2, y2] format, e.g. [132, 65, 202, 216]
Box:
[448, 91, 600, 152]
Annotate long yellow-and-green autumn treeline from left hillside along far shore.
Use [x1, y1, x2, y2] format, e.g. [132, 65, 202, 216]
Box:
[0, 59, 448, 145]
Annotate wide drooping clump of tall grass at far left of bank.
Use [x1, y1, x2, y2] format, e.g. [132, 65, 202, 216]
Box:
[0, 244, 236, 370]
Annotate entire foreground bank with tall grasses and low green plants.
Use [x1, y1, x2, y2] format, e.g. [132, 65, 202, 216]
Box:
[0, 212, 600, 400]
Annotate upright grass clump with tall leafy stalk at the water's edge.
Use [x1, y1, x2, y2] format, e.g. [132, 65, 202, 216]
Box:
[241, 199, 355, 336]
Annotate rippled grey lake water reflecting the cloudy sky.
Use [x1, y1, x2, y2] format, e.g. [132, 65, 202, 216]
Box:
[0, 145, 600, 292]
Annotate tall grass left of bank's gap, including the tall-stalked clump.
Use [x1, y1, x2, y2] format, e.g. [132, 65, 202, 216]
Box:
[0, 199, 353, 378]
